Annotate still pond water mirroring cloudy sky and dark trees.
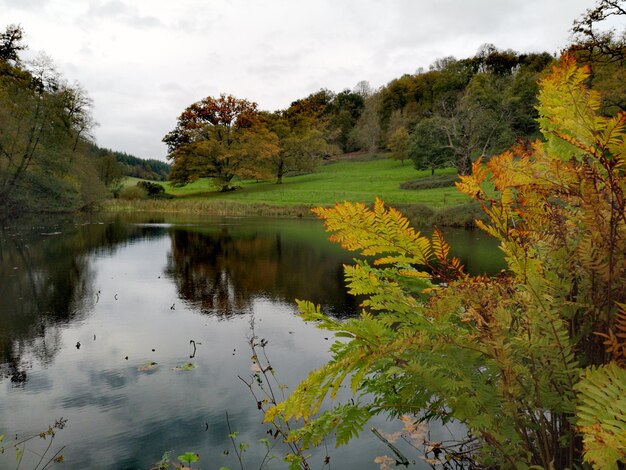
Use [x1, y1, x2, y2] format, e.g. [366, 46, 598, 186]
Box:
[0, 214, 503, 469]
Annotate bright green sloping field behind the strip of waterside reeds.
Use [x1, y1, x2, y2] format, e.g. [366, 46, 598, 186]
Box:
[158, 159, 468, 208]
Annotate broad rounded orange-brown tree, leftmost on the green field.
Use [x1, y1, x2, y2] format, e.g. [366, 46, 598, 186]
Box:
[163, 95, 278, 191]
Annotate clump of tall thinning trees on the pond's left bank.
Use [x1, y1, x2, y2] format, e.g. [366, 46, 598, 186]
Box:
[0, 44, 105, 212]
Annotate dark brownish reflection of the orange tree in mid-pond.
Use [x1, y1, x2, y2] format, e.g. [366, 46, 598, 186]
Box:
[166, 222, 357, 316]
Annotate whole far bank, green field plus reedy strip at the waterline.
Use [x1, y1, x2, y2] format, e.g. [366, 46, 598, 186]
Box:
[105, 159, 488, 226]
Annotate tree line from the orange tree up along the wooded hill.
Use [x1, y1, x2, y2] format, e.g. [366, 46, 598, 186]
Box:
[163, 45, 554, 186]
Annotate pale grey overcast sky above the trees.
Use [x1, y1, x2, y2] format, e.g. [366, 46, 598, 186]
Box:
[0, 0, 595, 160]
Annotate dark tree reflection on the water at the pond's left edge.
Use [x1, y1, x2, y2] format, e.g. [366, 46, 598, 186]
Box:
[0, 218, 165, 384]
